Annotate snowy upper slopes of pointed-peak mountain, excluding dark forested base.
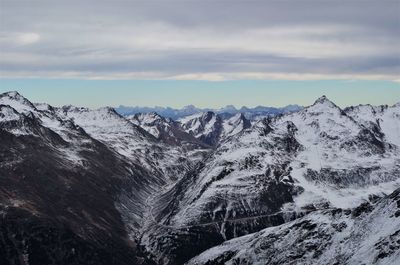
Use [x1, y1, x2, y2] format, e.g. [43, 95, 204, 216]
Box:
[158, 97, 400, 227]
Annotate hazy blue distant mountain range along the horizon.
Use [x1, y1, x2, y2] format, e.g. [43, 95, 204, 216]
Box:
[115, 105, 303, 120]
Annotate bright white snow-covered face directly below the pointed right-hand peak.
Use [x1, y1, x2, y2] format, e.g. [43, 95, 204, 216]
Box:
[276, 97, 400, 207]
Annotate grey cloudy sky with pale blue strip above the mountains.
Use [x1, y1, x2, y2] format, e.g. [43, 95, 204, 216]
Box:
[0, 0, 400, 106]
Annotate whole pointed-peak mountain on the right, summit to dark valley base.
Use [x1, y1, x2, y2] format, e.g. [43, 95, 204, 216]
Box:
[143, 97, 400, 264]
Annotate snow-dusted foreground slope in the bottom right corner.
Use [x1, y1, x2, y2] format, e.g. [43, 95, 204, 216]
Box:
[187, 187, 400, 265]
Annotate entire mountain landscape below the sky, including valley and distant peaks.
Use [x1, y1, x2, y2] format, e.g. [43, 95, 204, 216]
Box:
[0, 92, 400, 265]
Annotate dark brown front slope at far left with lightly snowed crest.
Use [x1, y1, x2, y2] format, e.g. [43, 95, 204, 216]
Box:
[0, 92, 152, 264]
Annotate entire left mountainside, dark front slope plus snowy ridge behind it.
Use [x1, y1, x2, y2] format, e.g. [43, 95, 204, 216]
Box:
[0, 92, 204, 264]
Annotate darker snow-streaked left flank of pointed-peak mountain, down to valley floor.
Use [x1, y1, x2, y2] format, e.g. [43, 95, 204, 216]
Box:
[141, 118, 299, 264]
